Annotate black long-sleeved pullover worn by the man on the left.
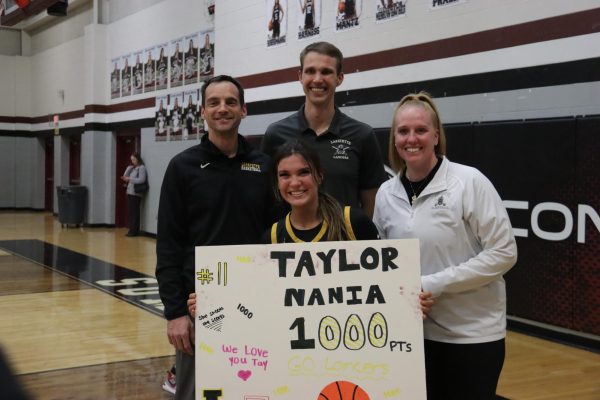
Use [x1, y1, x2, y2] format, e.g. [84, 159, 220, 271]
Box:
[156, 135, 276, 320]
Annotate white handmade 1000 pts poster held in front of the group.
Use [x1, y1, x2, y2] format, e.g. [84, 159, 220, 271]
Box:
[195, 239, 426, 400]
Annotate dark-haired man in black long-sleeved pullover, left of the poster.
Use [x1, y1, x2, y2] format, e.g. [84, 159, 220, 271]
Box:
[156, 75, 274, 399]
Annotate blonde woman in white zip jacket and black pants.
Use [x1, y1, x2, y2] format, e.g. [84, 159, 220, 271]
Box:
[373, 93, 517, 400]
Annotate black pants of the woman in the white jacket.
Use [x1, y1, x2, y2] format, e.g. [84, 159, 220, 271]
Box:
[425, 339, 504, 400]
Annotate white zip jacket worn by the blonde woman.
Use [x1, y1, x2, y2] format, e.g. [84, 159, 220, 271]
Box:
[373, 158, 517, 343]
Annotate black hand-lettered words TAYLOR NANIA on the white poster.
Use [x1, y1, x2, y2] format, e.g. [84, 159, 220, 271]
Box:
[271, 247, 398, 307]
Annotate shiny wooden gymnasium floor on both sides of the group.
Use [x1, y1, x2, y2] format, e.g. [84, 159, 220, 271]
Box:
[0, 212, 600, 400]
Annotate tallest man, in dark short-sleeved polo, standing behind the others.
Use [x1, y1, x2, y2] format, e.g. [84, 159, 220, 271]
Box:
[262, 42, 386, 217]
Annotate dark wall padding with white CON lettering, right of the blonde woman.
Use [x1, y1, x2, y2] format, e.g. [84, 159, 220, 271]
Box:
[447, 118, 600, 335]
